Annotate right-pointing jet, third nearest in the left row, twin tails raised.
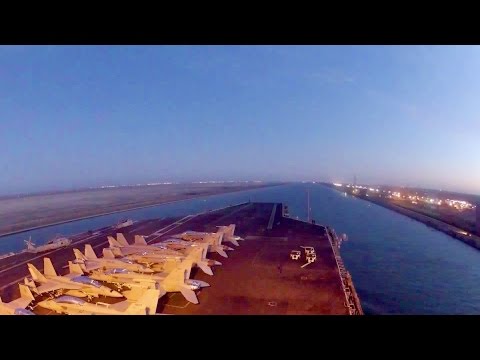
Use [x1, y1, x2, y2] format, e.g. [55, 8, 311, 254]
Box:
[73, 244, 153, 273]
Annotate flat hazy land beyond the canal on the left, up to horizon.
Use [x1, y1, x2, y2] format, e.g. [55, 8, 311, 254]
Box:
[0, 182, 274, 236]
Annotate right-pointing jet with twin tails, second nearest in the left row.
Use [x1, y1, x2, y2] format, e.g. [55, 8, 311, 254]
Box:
[27, 257, 123, 297]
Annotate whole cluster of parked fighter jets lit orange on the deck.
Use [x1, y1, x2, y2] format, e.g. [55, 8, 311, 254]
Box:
[0, 224, 243, 315]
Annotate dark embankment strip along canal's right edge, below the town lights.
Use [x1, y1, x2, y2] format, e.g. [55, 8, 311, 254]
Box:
[324, 184, 480, 250]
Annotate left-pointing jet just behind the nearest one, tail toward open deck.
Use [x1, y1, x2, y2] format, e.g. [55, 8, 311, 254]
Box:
[69, 259, 210, 304]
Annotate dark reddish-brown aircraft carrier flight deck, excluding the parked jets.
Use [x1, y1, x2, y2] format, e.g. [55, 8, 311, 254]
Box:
[0, 202, 363, 315]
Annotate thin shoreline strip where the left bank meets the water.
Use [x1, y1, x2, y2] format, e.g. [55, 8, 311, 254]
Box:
[0, 183, 284, 241]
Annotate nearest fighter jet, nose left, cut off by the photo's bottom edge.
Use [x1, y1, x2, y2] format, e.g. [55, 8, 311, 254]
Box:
[38, 289, 160, 315]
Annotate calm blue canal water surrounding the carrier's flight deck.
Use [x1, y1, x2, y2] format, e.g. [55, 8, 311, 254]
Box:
[0, 184, 480, 314]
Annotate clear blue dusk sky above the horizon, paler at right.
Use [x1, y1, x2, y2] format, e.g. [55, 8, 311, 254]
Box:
[0, 46, 480, 194]
